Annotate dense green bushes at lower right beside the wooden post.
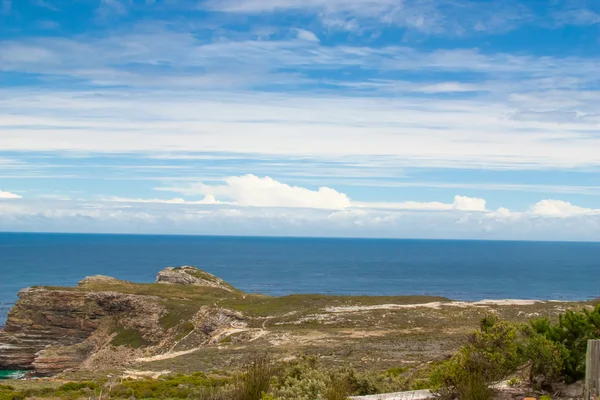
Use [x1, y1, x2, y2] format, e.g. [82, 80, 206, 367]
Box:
[430, 305, 600, 400]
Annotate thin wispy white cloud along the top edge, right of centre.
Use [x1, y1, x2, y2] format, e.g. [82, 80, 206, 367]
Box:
[203, 0, 530, 36]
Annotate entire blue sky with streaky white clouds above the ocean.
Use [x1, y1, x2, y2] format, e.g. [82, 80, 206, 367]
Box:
[0, 0, 600, 241]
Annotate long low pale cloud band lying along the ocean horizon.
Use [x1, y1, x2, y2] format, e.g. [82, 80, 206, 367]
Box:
[0, 195, 600, 241]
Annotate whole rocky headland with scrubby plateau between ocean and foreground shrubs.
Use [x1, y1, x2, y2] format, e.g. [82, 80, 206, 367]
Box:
[0, 266, 592, 376]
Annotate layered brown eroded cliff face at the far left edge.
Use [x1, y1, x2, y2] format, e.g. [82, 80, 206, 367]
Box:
[0, 288, 165, 375]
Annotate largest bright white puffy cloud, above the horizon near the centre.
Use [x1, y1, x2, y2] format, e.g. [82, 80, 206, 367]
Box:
[157, 175, 350, 209]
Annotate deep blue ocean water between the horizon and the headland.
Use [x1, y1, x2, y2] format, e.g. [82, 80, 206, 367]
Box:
[0, 233, 600, 325]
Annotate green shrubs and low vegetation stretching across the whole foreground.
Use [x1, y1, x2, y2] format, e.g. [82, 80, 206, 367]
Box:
[0, 305, 600, 400]
